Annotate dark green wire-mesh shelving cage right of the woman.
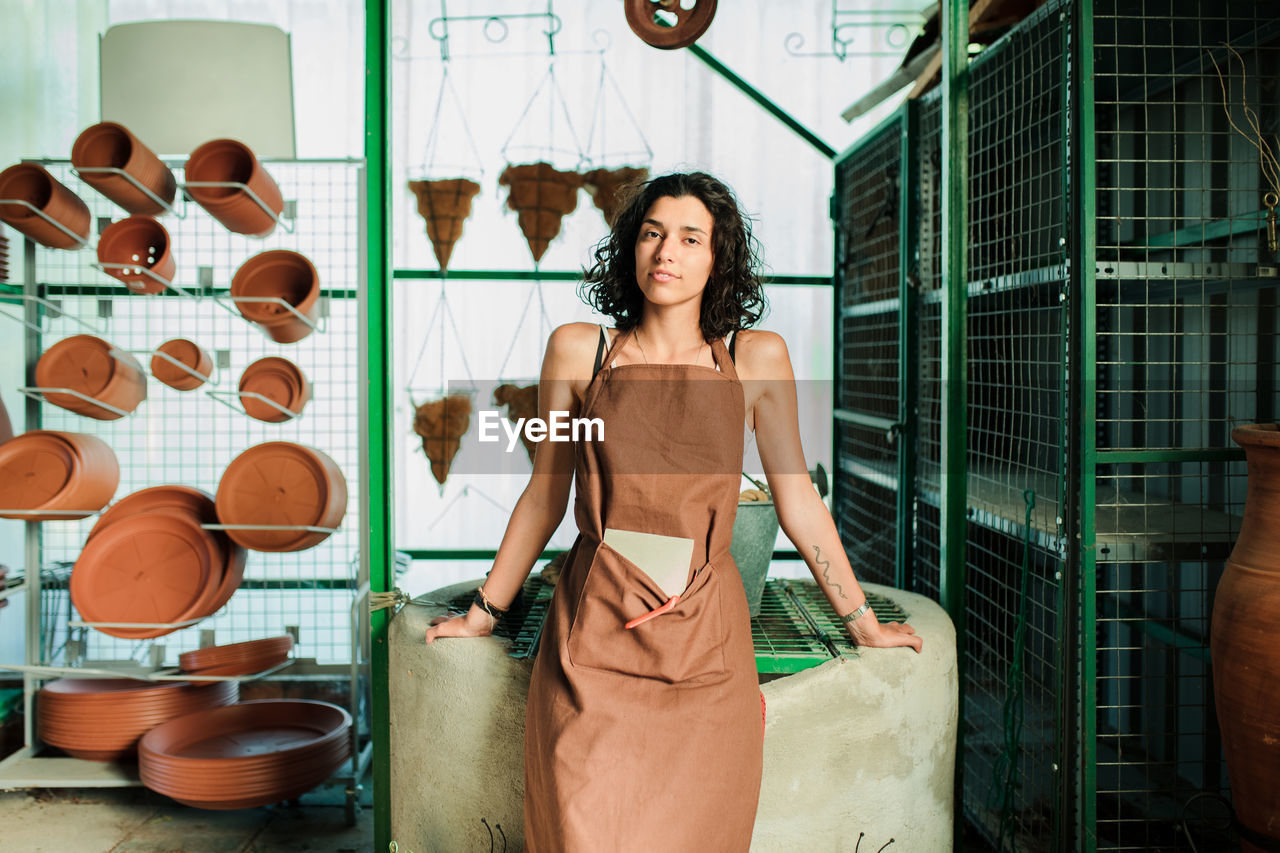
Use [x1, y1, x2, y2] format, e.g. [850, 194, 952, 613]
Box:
[836, 0, 1280, 850]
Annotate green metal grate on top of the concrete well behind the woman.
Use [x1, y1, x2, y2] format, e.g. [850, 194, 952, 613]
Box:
[448, 574, 908, 672]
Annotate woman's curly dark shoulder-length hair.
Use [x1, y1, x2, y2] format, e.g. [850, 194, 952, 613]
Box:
[579, 172, 765, 341]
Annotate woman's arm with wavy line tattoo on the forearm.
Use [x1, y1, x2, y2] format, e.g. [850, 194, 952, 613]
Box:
[739, 330, 923, 652]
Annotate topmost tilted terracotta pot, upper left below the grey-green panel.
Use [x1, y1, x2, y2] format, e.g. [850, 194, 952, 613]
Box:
[72, 122, 178, 216]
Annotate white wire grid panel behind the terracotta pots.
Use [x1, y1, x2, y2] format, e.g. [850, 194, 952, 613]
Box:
[18, 160, 362, 665]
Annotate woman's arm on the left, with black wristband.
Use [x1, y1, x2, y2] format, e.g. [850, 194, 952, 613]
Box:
[426, 323, 596, 643]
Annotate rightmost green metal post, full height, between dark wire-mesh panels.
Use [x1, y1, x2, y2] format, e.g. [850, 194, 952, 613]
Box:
[1064, 3, 1098, 853]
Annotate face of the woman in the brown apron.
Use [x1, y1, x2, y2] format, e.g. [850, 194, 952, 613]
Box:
[636, 196, 716, 305]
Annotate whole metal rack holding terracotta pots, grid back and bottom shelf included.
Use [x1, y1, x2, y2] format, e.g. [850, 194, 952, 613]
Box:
[0, 160, 372, 821]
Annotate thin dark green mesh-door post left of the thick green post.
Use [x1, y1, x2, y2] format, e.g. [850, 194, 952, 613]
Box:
[896, 100, 920, 589]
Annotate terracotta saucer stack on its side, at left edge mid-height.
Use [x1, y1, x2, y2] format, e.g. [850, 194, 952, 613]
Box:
[0, 429, 120, 521]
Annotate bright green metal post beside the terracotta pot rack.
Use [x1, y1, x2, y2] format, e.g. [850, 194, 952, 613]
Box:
[361, 0, 396, 850]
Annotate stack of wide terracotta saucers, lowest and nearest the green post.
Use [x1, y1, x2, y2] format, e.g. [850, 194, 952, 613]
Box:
[138, 699, 351, 808]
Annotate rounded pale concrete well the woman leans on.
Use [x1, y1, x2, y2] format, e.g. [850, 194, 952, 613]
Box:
[389, 580, 957, 853]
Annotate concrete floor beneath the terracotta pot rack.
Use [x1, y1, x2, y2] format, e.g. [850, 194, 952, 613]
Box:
[0, 780, 374, 853]
